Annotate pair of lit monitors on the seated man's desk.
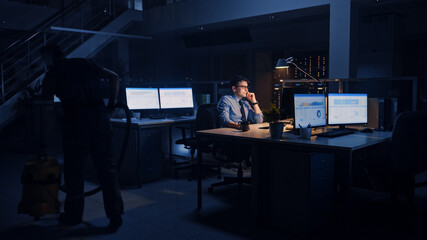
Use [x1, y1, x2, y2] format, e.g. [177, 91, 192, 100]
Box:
[294, 93, 368, 135]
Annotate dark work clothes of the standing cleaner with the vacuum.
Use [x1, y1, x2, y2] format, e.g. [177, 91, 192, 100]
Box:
[42, 55, 123, 228]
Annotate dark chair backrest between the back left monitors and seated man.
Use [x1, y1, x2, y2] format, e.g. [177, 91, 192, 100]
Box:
[194, 104, 219, 131]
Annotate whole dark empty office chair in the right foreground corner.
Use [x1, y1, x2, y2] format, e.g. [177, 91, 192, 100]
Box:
[356, 111, 427, 229]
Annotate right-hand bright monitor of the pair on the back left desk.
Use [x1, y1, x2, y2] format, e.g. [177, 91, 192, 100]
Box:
[159, 88, 194, 109]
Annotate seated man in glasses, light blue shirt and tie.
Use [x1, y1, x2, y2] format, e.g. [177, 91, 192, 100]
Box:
[217, 75, 264, 130]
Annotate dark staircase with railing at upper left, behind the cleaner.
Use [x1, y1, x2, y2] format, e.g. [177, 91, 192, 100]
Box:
[0, 0, 127, 105]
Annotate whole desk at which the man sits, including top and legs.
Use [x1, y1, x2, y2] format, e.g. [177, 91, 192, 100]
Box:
[196, 123, 391, 235]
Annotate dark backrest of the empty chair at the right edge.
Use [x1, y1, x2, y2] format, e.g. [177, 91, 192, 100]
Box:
[390, 111, 427, 175]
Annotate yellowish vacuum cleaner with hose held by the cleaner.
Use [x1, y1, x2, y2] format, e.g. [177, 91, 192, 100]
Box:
[18, 102, 131, 220]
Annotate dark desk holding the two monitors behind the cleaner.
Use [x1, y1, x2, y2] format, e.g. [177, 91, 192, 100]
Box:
[111, 116, 195, 187]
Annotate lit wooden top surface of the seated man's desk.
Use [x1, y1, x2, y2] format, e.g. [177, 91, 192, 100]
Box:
[196, 123, 391, 150]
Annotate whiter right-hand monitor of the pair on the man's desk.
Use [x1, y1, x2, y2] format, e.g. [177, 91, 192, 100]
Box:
[328, 93, 368, 127]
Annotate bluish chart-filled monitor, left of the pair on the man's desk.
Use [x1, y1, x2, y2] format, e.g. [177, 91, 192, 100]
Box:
[294, 94, 326, 128]
